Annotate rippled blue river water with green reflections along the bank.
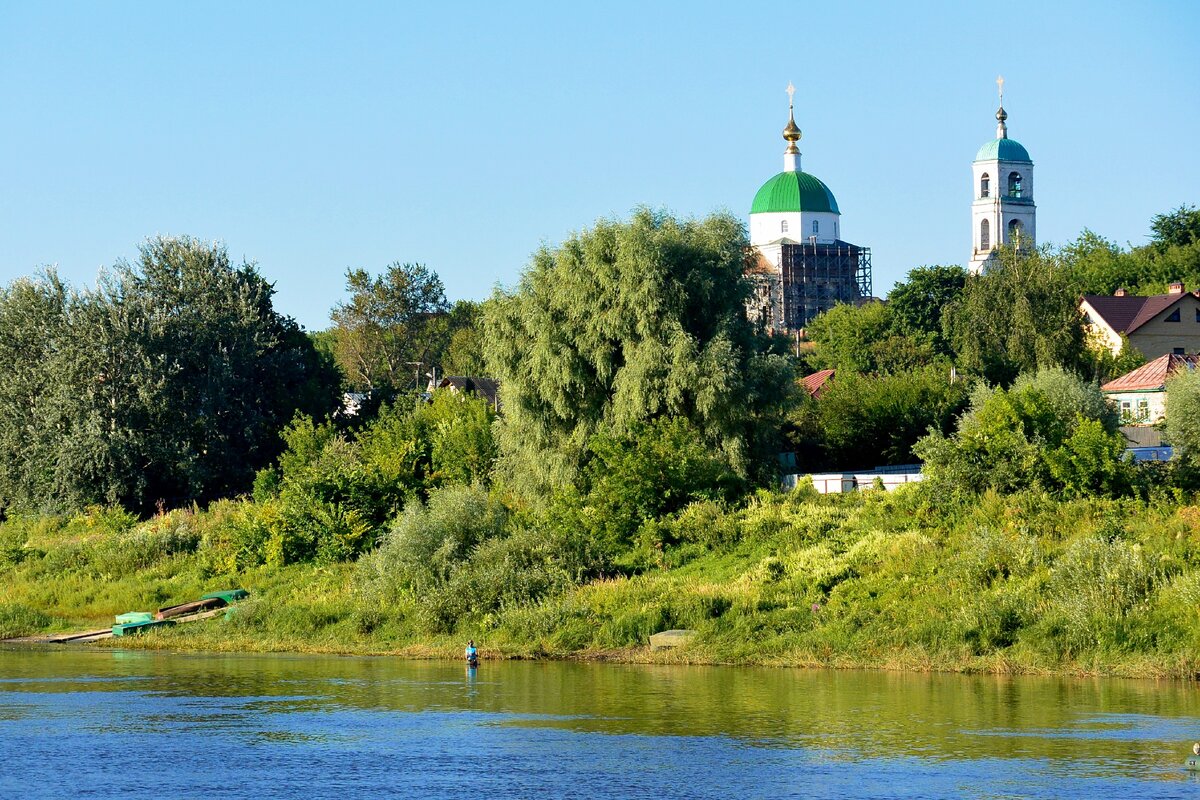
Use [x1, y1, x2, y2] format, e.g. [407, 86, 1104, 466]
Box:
[0, 648, 1200, 800]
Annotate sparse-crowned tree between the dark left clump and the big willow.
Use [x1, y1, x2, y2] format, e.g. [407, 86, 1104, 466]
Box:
[332, 261, 449, 395]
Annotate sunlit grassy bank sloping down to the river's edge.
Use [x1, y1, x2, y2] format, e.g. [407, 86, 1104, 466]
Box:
[0, 488, 1200, 678]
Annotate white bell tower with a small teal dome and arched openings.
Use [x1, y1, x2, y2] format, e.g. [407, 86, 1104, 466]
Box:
[968, 78, 1037, 273]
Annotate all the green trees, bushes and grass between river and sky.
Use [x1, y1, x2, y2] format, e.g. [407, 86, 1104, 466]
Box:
[0, 209, 1200, 678]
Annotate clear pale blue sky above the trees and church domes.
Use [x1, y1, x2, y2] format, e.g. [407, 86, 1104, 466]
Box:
[0, 0, 1200, 329]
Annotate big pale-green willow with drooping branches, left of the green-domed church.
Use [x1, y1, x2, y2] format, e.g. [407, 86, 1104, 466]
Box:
[485, 209, 791, 495]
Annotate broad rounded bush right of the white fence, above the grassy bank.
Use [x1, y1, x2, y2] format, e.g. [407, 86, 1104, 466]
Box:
[914, 368, 1129, 494]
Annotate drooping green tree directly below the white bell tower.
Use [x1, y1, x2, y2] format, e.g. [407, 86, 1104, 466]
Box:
[943, 248, 1086, 385]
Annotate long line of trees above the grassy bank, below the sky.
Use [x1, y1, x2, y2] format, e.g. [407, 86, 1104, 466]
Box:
[0, 206, 1200, 522]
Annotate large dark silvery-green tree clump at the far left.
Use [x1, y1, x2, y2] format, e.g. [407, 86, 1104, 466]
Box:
[0, 237, 337, 512]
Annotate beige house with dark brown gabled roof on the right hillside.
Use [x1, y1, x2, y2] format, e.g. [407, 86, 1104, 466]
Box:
[1079, 283, 1200, 357]
